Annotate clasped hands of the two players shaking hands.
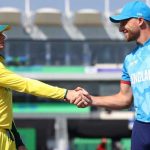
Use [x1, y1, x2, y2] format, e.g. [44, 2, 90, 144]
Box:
[64, 87, 92, 108]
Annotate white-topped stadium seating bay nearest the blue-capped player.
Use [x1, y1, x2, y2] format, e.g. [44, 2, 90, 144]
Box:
[73, 9, 109, 39]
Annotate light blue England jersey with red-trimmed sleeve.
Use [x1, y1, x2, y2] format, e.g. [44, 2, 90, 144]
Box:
[121, 40, 150, 122]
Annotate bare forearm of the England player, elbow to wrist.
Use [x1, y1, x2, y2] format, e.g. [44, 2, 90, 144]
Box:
[91, 94, 132, 110]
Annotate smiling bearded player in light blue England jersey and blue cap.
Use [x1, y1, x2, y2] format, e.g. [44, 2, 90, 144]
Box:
[77, 0, 150, 150]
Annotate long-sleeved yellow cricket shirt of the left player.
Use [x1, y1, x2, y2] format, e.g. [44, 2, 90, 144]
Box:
[0, 58, 66, 129]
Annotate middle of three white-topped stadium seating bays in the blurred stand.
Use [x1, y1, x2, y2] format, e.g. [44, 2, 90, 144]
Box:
[33, 8, 69, 39]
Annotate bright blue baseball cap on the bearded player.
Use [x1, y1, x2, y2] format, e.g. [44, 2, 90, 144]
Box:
[110, 0, 150, 23]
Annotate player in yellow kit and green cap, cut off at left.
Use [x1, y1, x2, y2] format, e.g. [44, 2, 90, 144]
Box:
[0, 25, 90, 150]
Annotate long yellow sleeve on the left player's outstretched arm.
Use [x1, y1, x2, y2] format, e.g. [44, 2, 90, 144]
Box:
[0, 63, 66, 99]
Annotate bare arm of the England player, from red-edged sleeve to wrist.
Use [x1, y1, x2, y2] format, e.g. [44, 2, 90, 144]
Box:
[91, 83, 132, 109]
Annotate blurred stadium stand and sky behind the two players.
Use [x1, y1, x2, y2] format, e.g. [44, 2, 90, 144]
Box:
[0, 0, 149, 150]
